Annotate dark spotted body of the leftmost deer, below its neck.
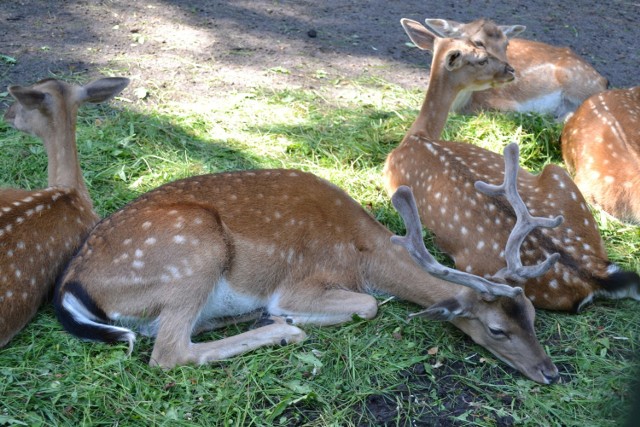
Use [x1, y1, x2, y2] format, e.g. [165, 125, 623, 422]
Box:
[0, 188, 96, 346]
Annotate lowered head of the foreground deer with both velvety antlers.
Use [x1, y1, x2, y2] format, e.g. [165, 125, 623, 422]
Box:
[392, 143, 563, 383]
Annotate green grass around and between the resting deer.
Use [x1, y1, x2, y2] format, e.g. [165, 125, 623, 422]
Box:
[0, 75, 640, 427]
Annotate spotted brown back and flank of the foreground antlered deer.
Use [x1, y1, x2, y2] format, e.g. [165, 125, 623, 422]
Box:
[62, 170, 388, 306]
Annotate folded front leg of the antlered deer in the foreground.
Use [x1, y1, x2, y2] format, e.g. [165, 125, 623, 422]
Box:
[267, 277, 378, 326]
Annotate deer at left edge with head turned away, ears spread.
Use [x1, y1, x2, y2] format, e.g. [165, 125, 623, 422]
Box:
[0, 78, 128, 346]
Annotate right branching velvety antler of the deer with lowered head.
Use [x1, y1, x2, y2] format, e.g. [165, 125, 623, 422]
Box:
[475, 142, 564, 282]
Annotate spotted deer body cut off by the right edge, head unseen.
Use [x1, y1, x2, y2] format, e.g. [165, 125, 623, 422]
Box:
[560, 86, 640, 223]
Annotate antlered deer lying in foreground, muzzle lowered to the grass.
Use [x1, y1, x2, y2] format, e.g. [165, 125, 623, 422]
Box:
[54, 159, 558, 383]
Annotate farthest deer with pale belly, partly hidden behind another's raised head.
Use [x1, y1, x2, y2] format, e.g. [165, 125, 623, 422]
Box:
[426, 19, 608, 120]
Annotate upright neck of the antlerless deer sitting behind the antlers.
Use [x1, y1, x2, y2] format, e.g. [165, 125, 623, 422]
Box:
[407, 65, 460, 140]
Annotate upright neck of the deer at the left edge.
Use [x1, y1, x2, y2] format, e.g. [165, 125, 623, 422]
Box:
[43, 109, 93, 209]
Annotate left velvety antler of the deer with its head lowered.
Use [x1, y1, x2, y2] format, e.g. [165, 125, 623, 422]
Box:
[391, 185, 522, 298]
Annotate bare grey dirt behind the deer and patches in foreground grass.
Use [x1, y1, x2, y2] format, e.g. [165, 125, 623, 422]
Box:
[0, 0, 640, 425]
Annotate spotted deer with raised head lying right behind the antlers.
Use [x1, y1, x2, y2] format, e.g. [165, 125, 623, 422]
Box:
[384, 20, 640, 312]
